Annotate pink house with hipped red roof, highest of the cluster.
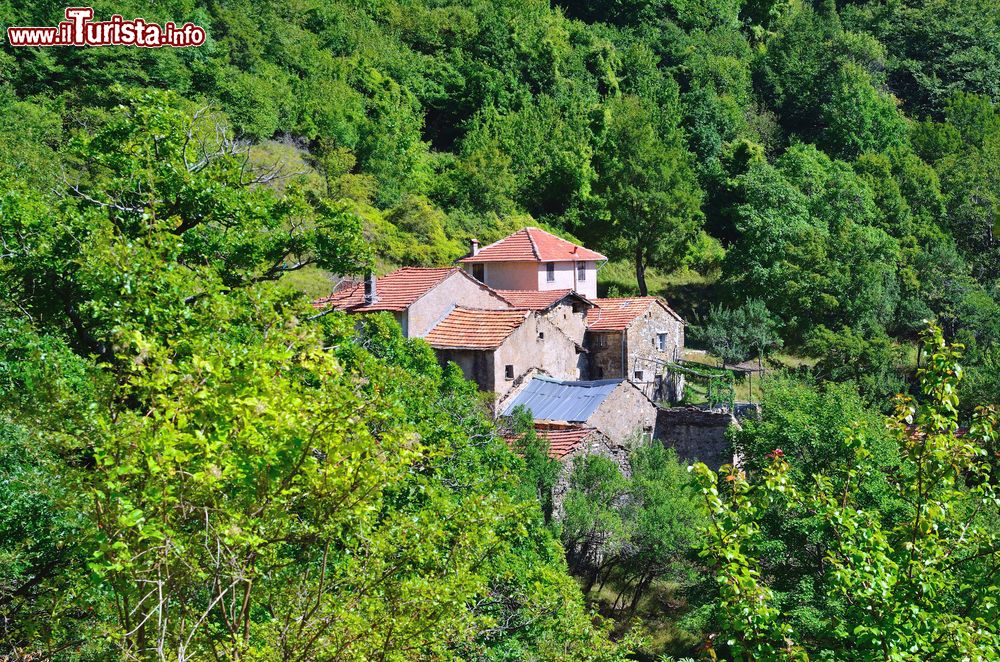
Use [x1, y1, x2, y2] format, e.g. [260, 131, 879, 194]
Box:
[459, 227, 607, 299]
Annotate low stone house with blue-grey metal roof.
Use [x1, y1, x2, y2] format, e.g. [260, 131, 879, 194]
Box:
[499, 376, 657, 446]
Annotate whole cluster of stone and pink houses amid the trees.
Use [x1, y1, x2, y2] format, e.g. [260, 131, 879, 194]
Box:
[314, 227, 737, 486]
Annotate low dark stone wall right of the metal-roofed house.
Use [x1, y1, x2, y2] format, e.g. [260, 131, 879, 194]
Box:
[654, 407, 740, 471]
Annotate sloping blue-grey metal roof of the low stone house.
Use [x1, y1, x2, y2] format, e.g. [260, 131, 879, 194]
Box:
[504, 377, 623, 423]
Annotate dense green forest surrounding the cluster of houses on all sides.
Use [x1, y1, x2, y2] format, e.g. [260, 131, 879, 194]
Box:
[0, 0, 1000, 660]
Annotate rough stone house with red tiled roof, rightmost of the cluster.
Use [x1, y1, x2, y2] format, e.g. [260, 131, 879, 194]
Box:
[585, 297, 684, 401]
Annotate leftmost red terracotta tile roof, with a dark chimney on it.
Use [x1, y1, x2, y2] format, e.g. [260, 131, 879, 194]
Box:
[313, 267, 462, 312]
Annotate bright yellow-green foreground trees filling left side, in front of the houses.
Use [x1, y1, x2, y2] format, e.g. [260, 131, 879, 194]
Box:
[0, 93, 629, 660]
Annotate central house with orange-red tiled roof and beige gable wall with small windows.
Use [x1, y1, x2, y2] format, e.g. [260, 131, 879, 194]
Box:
[424, 306, 586, 397]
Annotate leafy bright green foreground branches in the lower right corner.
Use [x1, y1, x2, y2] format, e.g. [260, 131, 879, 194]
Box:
[697, 326, 1000, 659]
